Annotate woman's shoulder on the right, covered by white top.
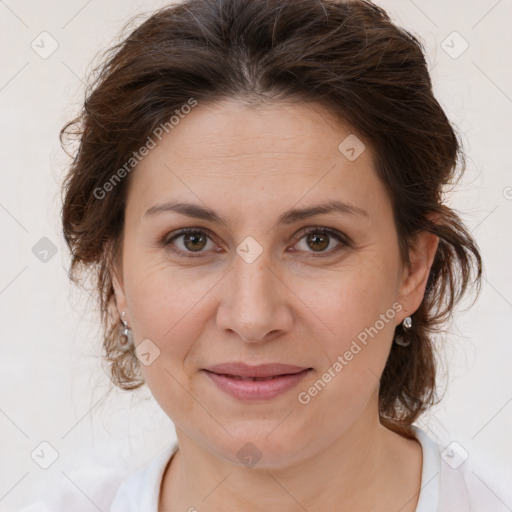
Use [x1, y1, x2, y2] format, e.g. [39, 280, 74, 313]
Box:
[414, 427, 512, 512]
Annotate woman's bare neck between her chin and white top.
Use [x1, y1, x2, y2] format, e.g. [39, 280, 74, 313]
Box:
[160, 406, 422, 512]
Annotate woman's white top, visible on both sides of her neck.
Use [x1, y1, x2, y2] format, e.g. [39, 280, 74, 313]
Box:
[20, 427, 512, 512]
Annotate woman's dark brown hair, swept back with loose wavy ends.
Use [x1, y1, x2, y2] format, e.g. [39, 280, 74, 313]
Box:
[61, 0, 482, 434]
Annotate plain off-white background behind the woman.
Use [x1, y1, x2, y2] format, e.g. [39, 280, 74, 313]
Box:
[0, 0, 512, 510]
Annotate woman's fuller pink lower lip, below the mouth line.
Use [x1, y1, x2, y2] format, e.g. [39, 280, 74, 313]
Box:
[205, 369, 310, 400]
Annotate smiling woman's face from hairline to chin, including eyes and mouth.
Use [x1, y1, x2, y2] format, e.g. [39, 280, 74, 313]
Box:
[114, 101, 433, 467]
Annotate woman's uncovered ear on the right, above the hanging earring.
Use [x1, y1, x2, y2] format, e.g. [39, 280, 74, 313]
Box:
[398, 217, 439, 316]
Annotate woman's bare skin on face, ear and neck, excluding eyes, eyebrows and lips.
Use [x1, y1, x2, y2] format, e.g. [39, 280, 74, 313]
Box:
[112, 100, 438, 512]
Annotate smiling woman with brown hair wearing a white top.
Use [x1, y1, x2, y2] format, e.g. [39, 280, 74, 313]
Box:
[19, 0, 506, 512]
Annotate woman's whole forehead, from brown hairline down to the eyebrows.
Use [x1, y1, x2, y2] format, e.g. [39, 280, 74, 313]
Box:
[128, 100, 389, 222]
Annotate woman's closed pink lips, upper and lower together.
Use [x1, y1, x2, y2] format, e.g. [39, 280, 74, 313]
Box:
[204, 363, 311, 400]
